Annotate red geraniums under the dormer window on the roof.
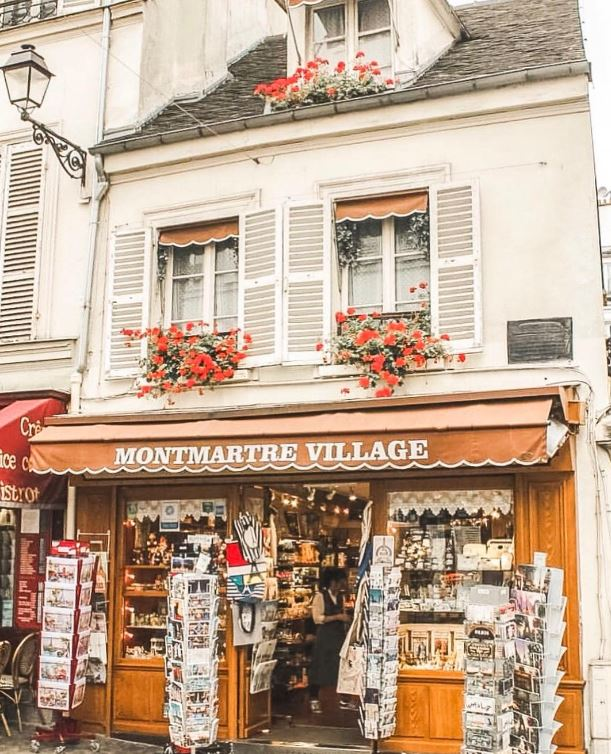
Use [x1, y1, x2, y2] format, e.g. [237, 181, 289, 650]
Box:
[254, 52, 395, 111]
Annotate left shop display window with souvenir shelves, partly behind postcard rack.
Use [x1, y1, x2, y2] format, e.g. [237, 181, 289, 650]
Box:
[117, 498, 228, 665]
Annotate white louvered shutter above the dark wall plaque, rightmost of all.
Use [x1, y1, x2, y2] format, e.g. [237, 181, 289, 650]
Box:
[430, 184, 482, 351]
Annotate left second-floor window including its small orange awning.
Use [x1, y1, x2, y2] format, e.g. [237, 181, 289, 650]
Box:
[159, 220, 238, 332]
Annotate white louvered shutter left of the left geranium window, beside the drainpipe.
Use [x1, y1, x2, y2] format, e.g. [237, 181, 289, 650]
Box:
[106, 229, 150, 378]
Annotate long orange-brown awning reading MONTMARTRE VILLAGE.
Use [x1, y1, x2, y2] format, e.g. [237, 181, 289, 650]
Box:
[31, 397, 568, 474]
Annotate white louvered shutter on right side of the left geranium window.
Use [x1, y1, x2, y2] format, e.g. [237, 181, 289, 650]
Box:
[240, 209, 282, 367]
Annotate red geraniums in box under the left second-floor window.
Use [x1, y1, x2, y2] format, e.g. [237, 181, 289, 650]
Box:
[121, 322, 251, 398]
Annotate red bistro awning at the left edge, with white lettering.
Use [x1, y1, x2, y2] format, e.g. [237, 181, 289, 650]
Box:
[0, 398, 66, 508]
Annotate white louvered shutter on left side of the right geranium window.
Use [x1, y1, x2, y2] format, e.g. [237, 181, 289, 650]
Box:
[283, 202, 331, 363]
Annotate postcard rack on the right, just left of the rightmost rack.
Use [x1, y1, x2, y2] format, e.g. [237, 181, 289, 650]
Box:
[463, 586, 516, 754]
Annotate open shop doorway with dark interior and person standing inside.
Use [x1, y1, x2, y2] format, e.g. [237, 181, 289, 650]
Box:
[253, 482, 370, 745]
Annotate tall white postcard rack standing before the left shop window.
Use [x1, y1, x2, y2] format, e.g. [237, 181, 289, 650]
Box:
[165, 572, 219, 748]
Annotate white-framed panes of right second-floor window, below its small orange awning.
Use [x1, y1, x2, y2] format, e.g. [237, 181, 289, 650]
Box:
[341, 215, 431, 313]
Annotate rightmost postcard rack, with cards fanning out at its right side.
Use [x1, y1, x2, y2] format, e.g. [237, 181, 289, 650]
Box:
[511, 553, 566, 754]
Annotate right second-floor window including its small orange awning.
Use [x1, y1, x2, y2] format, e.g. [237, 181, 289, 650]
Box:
[336, 192, 430, 313]
